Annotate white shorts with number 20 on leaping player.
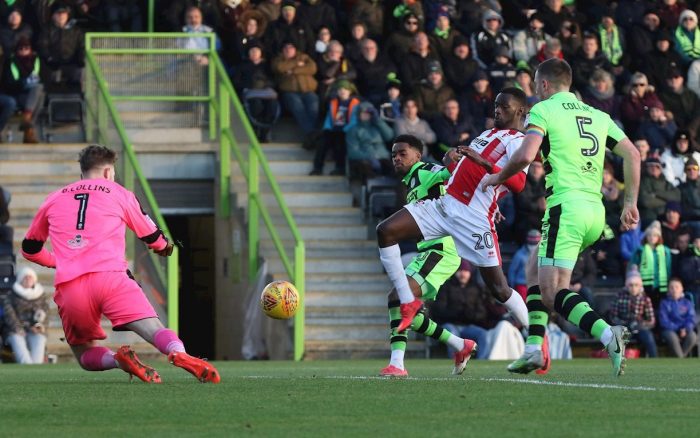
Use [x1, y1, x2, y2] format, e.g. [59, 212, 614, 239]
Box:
[404, 195, 501, 267]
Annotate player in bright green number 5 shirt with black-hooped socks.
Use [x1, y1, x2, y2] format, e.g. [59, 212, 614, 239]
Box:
[482, 58, 640, 376]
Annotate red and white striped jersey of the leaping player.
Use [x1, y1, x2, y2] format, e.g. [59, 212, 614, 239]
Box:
[447, 128, 527, 219]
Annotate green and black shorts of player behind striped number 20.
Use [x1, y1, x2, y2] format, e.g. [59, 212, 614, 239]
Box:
[405, 237, 462, 300]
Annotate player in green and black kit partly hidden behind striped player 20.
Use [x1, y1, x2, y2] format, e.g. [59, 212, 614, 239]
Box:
[380, 135, 477, 377]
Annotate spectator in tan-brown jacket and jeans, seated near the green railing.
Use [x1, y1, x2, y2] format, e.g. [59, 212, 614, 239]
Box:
[272, 41, 319, 136]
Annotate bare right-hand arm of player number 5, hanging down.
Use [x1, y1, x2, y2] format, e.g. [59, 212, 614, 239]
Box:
[608, 130, 641, 229]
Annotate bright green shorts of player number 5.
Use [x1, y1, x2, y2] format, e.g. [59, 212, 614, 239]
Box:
[537, 199, 605, 269]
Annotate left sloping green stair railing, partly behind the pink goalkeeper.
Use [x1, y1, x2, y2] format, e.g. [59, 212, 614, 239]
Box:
[85, 51, 179, 332]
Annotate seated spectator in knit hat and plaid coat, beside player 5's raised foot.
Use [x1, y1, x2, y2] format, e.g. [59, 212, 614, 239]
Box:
[610, 270, 657, 357]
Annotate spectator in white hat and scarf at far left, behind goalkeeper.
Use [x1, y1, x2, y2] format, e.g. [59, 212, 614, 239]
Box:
[1, 268, 49, 364]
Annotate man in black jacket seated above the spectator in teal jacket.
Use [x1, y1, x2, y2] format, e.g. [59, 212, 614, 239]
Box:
[355, 38, 400, 106]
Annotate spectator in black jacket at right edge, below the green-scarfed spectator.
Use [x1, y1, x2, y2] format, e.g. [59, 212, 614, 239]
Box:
[659, 68, 700, 132]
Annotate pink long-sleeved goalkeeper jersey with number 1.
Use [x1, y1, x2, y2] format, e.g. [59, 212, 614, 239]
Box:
[22, 179, 167, 284]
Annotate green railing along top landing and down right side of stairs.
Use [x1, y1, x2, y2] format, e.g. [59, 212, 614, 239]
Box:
[86, 33, 305, 360]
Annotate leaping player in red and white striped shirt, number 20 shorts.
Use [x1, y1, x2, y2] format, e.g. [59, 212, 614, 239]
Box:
[377, 87, 528, 356]
